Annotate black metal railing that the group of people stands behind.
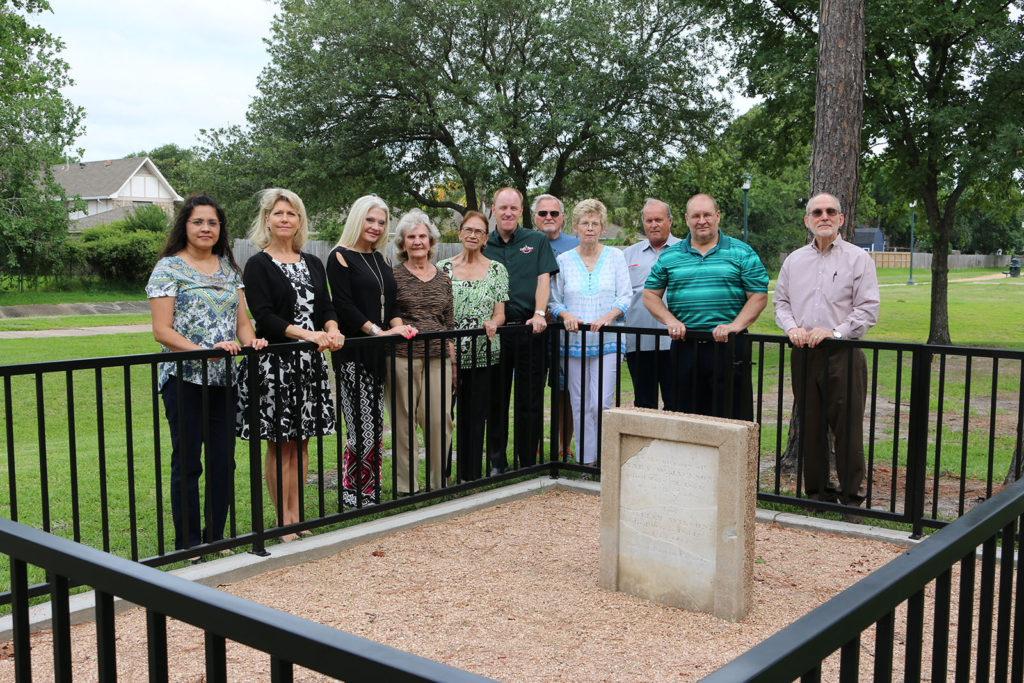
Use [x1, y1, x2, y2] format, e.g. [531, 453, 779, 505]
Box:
[0, 325, 1024, 603]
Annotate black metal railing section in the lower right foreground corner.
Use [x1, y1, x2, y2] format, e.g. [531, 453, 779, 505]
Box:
[703, 466, 1024, 683]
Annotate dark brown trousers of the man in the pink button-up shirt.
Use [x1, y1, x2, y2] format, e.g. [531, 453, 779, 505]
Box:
[792, 346, 867, 505]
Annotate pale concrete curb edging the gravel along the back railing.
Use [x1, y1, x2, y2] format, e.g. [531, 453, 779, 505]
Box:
[0, 477, 920, 642]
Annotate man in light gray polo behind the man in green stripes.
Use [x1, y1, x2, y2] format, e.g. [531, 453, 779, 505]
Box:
[623, 199, 679, 411]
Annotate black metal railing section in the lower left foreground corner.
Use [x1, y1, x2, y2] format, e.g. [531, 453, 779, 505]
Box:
[0, 518, 490, 683]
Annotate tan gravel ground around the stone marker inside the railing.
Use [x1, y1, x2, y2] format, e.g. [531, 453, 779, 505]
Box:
[0, 490, 950, 681]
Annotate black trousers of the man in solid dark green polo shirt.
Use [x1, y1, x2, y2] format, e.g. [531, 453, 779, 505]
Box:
[487, 321, 548, 472]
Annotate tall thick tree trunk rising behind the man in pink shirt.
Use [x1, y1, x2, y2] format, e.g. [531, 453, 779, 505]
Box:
[782, 0, 864, 470]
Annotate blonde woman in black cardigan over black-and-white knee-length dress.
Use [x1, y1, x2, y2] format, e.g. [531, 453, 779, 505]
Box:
[238, 188, 345, 541]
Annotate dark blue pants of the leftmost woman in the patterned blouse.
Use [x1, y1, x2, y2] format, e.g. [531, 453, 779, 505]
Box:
[162, 376, 234, 550]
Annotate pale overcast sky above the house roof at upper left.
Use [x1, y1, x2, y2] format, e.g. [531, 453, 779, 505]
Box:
[36, 0, 276, 161]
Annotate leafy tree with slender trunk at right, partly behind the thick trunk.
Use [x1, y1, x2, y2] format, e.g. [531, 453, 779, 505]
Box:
[709, 0, 1024, 344]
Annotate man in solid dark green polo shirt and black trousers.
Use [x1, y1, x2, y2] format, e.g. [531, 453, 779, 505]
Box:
[486, 187, 558, 474]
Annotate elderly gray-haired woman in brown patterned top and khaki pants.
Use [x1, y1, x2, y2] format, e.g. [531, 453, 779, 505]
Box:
[388, 209, 455, 495]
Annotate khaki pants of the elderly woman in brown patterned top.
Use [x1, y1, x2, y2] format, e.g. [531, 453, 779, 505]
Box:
[387, 356, 453, 495]
